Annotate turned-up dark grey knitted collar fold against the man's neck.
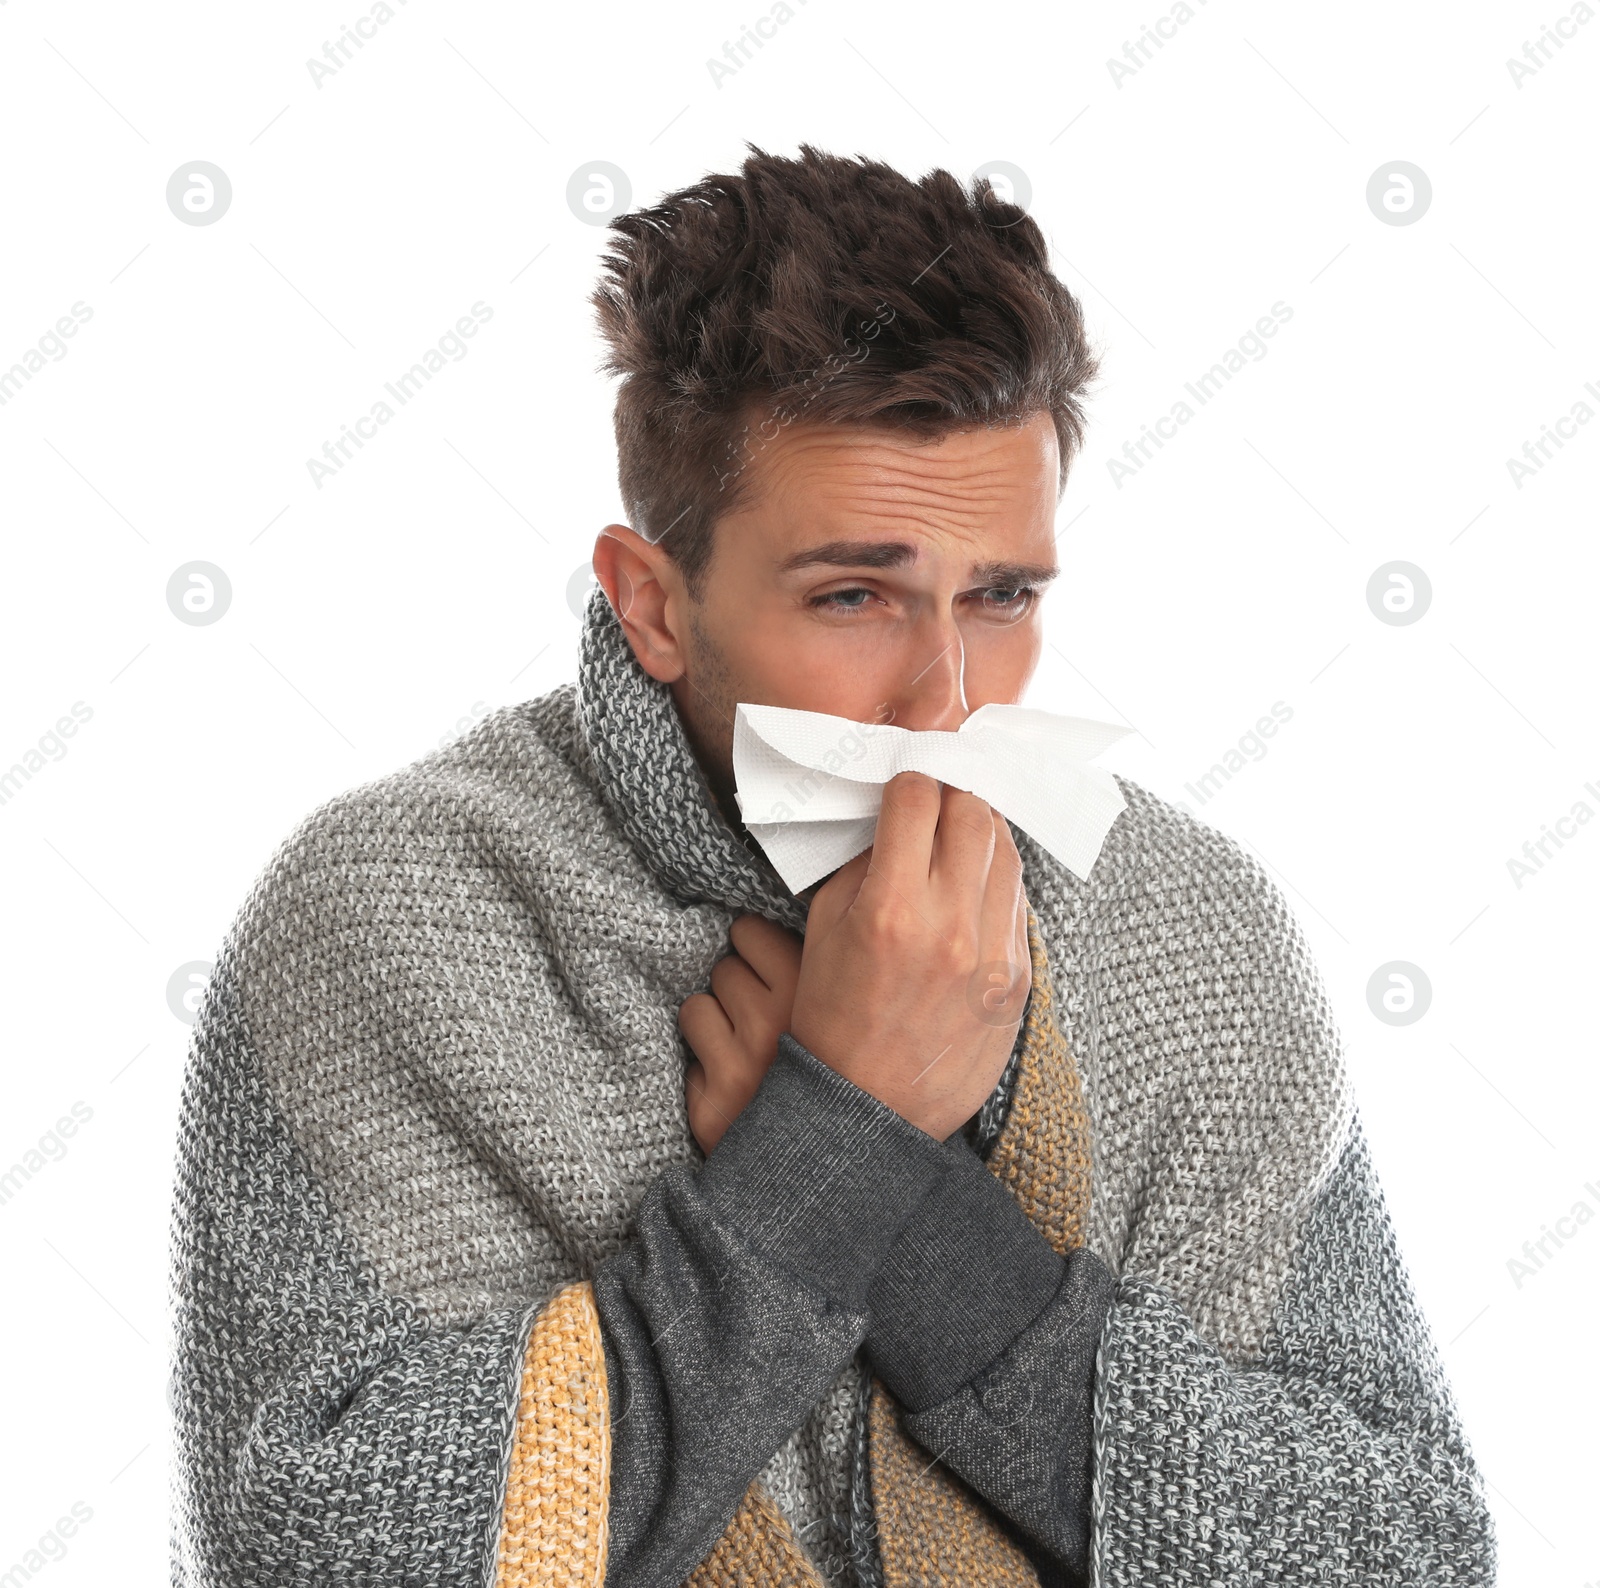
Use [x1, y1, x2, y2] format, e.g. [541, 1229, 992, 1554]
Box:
[578, 584, 806, 932]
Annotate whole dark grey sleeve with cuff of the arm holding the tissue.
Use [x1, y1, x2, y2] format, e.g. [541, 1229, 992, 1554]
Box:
[594, 1034, 950, 1588]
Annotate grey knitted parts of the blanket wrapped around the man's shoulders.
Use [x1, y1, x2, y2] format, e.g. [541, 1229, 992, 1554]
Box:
[171, 592, 1494, 1588]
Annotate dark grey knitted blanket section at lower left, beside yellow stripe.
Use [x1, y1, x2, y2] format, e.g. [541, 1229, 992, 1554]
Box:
[170, 933, 531, 1588]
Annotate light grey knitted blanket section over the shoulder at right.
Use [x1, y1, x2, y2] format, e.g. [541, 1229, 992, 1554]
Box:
[1018, 794, 1354, 1365]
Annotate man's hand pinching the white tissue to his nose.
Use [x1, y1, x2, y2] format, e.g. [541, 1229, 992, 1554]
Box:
[789, 772, 1032, 1141]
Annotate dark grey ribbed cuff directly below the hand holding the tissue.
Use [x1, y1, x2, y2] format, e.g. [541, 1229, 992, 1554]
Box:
[699, 1031, 950, 1311]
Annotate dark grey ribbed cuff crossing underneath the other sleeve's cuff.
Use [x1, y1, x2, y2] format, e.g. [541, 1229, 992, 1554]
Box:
[866, 1135, 1066, 1412]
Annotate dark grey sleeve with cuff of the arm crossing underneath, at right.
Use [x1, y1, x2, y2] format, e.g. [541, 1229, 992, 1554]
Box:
[866, 1135, 1115, 1580]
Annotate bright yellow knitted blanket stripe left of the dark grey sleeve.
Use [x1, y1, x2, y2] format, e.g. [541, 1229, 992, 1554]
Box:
[496, 1284, 611, 1588]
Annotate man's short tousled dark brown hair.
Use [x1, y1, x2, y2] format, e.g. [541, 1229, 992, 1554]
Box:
[594, 144, 1096, 599]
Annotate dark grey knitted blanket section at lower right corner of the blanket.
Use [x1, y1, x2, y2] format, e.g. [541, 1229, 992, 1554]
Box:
[1090, 1119, 1494, 1588]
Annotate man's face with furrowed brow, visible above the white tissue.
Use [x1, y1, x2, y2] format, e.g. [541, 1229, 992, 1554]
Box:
[595, 403, 1058, 818]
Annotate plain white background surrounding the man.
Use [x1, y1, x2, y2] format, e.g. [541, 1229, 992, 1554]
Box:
[0, 0, 1600, 1588]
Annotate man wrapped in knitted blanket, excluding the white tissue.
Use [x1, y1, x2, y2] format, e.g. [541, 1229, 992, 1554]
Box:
[173, 149, 1494, 1588]
